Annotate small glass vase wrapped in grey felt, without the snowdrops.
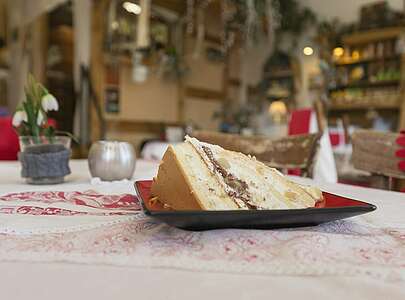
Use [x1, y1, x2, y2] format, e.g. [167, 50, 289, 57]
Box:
[19, 136, 71, 184]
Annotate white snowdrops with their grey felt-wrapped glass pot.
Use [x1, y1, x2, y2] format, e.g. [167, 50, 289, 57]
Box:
[13, 75, 72, 184]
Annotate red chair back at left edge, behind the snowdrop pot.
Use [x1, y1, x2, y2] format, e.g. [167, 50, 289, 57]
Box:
[0, 116, 20, 160]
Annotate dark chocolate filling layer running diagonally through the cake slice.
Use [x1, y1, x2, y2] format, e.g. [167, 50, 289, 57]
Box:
[202, 146, 257, 209]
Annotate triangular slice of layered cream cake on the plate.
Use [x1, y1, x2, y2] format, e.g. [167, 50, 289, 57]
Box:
[152, 137, 322, 210]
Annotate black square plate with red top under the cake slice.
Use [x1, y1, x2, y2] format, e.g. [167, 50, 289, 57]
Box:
[135, 180, 377, 230]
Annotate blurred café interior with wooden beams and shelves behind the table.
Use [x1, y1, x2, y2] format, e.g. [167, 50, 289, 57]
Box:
[0, 0, 405, 190]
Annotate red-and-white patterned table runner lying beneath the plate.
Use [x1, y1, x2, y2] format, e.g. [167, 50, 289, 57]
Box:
[0, 191, 405, 284]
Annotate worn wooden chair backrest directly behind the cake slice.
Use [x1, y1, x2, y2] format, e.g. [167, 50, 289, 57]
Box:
[193, 131, 321, 177]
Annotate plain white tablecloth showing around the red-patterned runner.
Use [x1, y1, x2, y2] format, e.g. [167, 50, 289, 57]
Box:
[0, 160, 405, 299]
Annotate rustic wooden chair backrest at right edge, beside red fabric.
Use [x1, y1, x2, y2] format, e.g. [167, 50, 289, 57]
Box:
[352, 130, 405, 190]
